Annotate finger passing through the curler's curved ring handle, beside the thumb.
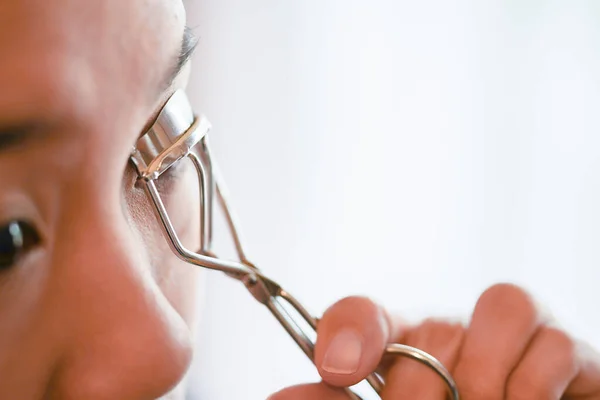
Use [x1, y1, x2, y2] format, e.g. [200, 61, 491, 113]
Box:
[382, 320, 465, 400]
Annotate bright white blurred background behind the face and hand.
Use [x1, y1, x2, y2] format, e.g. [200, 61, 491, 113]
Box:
[188, 0, 600, 400]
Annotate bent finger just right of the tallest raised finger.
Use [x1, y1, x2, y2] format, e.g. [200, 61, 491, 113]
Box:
[506, 327, 578, 400]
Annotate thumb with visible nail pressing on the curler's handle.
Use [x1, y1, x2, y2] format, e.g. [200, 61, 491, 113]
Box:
[315, 297, 402, 386]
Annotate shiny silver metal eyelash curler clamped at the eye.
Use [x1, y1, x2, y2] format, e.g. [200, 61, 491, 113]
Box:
[131, 90, 459, 400]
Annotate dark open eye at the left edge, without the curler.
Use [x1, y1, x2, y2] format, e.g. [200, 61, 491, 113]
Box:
[0, 221, 40, 271]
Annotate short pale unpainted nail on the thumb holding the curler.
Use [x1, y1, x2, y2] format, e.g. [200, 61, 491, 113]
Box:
[321, 329, 362, 375]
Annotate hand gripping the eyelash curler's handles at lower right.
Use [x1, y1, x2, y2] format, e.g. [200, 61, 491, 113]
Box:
[269, 285, 600, 400]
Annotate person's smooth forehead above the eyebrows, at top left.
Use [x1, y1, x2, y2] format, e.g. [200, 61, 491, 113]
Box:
[0, 0, 184, 124]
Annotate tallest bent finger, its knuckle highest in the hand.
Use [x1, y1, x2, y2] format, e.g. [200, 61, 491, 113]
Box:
[454, 284, 542, 400]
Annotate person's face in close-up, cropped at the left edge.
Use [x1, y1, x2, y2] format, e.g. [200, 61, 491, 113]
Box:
[0, 0, 199, 400]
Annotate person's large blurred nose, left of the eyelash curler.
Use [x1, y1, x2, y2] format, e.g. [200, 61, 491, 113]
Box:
[48, 186, 192, 400]
